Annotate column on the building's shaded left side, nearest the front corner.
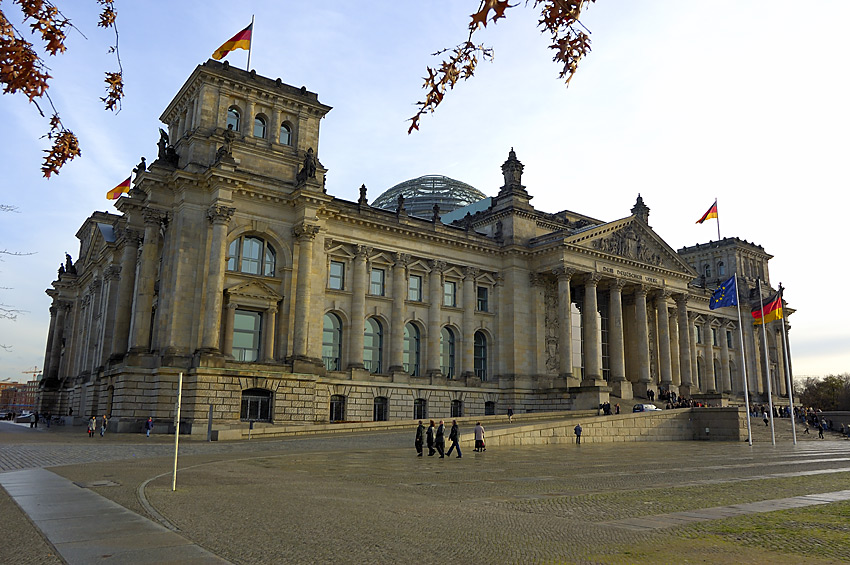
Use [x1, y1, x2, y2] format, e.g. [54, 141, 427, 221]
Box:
[130, 208, 165, 353]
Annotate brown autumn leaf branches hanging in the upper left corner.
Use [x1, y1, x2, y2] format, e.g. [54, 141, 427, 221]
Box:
[0, 0, 124, 178]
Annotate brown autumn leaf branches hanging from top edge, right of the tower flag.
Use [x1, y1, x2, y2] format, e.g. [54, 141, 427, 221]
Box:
[407, 0, 596, 133]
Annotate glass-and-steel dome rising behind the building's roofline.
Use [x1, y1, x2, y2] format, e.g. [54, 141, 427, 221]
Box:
[372, 175, 487, 219]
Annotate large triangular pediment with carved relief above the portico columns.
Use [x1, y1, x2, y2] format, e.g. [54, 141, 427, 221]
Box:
[565, 216, 697, 277]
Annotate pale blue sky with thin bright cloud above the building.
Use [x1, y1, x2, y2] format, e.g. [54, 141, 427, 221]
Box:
[0, 0, 850, 380]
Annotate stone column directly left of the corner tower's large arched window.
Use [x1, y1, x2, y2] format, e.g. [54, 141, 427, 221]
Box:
[201, 204, 236, 353]
